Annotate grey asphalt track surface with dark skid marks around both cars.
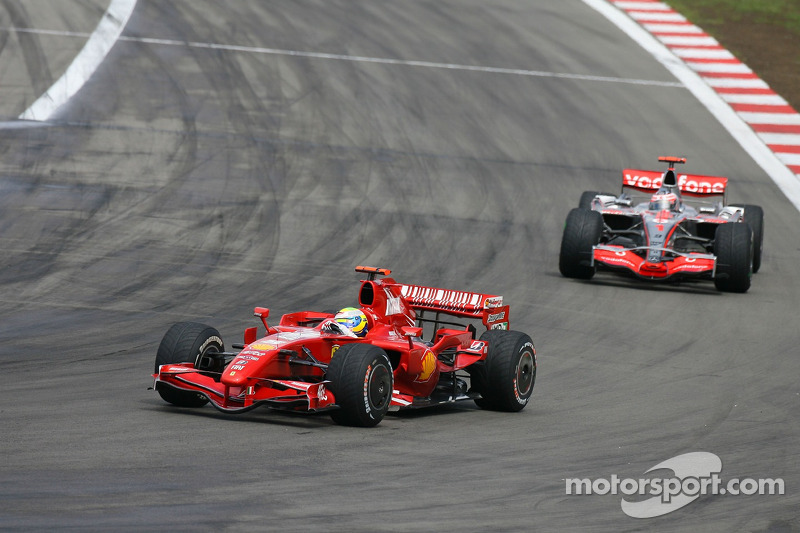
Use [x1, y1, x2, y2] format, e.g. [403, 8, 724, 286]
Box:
[0, 0, 800, 531]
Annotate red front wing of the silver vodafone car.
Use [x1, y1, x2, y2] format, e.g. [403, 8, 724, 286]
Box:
[592, 245, 717, 279]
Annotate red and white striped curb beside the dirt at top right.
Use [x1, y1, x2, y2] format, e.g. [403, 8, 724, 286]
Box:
[610, 0, 800, 177]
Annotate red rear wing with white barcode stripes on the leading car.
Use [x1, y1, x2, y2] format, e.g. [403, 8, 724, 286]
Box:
[400, 284, 509, 329]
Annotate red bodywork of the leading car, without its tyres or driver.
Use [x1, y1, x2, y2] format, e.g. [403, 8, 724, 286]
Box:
[153, 267, 509, 412]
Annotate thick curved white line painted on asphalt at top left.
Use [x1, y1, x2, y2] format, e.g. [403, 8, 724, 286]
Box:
[19, 0, 136, 121]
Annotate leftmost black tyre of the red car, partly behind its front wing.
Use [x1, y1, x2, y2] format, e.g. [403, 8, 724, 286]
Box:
[155, 322, 225, 407]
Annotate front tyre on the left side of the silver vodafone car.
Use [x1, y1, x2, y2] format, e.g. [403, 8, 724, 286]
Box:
[558, 207, 603, 279]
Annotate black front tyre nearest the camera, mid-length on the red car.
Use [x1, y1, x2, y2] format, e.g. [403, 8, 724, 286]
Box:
[325, 343, 394, 427]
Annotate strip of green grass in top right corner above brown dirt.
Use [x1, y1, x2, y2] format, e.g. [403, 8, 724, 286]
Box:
[666, 0, 800, 35]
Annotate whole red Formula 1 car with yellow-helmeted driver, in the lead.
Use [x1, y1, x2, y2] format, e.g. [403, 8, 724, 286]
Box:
[153, 267, 536, 427]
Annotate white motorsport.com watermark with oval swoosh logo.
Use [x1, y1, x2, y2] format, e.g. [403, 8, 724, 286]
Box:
[565, 452, 784, 518]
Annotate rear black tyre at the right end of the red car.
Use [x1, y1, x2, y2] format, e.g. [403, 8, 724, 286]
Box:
[470, 329, 536, 412]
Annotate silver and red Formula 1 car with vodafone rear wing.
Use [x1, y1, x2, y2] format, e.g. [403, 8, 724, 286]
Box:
[559, 157, 764, 292]
